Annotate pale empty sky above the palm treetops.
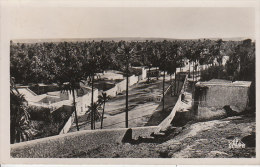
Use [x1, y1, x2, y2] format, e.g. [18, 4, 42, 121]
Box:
[6, 6, 255, 39]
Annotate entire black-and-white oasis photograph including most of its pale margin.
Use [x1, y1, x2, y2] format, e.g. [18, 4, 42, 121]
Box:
[1, 1, 259, 163]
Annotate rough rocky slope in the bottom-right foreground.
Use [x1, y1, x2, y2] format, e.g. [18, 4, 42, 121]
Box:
[63, 115, 256, 158]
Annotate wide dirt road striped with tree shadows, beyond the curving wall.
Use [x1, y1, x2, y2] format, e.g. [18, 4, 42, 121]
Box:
[69, 77, 173, 132]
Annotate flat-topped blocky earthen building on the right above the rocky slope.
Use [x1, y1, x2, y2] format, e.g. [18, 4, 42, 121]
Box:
[194, 81, 251, 119]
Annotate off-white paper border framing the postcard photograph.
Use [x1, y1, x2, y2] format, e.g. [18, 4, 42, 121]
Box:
[0, 0, 260, 165]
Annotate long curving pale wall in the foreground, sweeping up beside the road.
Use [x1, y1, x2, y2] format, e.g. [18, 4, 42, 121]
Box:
[10, 75, 187, 158]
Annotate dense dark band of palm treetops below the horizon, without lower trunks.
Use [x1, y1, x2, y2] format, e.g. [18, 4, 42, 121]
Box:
[10, 40, 255, 84]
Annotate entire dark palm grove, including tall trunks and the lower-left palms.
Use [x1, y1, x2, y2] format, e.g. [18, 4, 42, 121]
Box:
[10, 39, 255, 143]
